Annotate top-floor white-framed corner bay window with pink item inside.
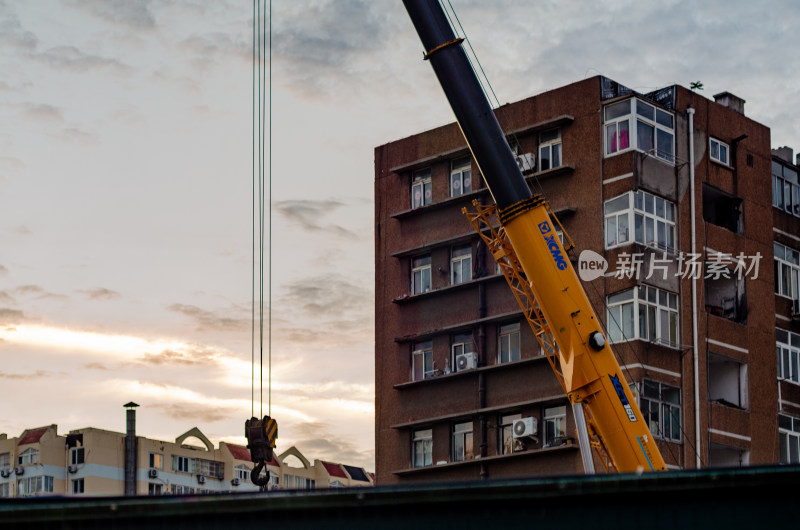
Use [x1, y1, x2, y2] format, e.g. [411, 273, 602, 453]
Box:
[603, 98, 675, 162]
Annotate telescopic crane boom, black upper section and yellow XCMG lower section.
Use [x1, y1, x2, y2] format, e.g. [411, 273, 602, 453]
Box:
[403, 0, 666, 471]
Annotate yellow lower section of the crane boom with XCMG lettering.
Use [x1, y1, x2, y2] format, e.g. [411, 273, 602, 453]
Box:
[503, 201, 666, 472]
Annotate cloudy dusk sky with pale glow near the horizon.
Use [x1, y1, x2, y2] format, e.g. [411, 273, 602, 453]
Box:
[0, 0, 800, 470]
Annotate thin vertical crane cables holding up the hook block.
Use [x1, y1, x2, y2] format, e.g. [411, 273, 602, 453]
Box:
[250, 0, 272, 416]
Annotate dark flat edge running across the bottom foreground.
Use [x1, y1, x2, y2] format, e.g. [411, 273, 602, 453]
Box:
[0, 466, 800, 530]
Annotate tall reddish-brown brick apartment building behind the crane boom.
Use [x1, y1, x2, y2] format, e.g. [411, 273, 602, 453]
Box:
[375, 76, 800, 484]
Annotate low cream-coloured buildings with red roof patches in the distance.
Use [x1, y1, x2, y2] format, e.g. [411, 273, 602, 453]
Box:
[0, 425, 374, 497]
